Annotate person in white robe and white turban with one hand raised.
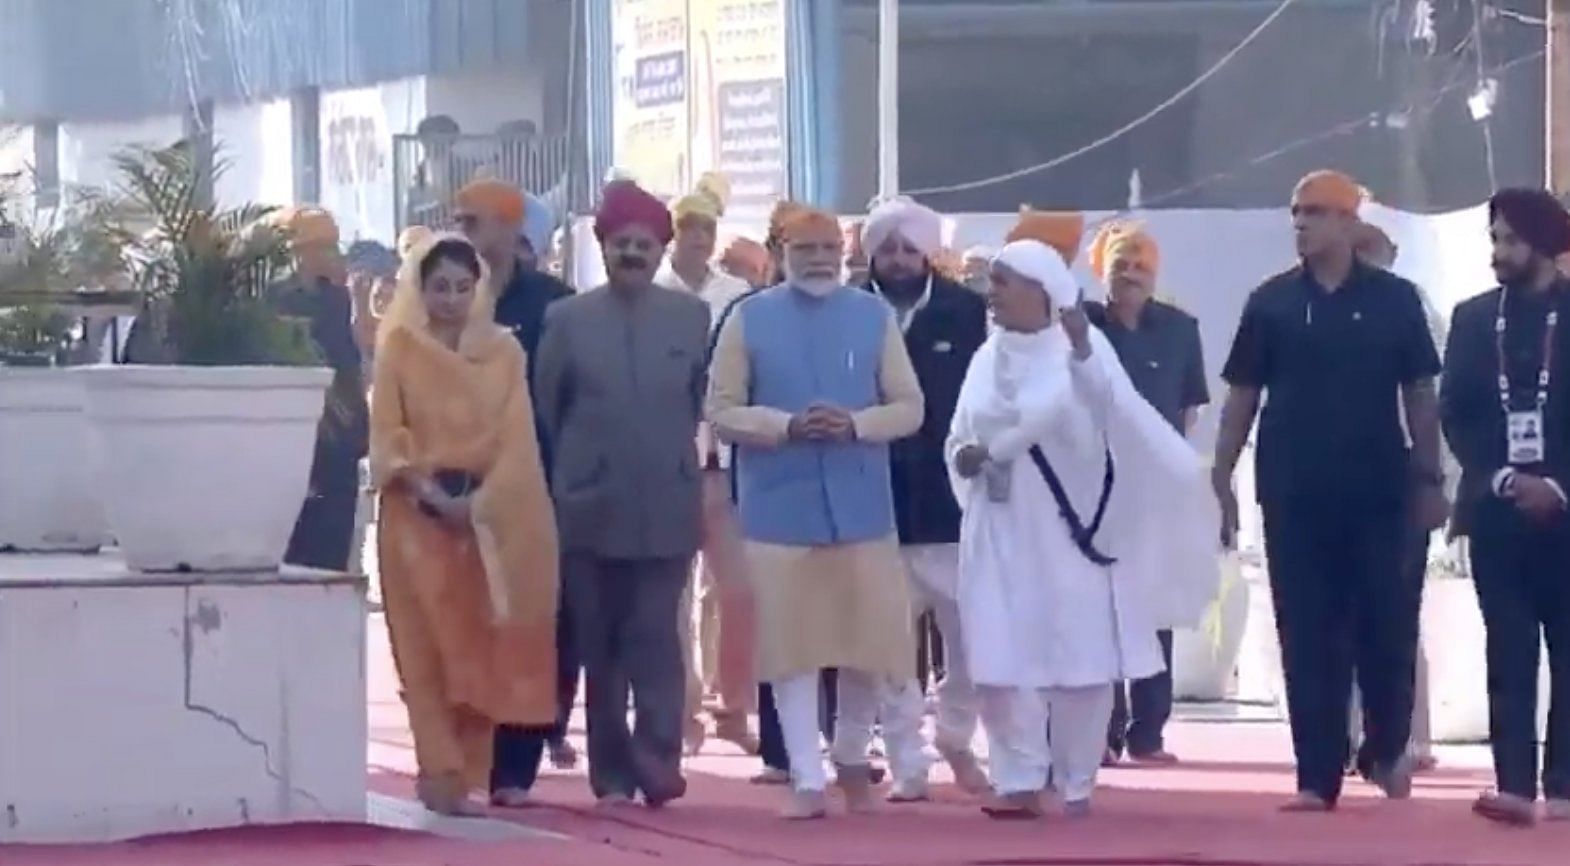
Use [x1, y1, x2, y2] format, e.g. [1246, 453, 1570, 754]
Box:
[947, 240, 1220, 817]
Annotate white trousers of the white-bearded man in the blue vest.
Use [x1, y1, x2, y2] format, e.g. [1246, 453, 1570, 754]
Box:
[772, 668, 885, 791]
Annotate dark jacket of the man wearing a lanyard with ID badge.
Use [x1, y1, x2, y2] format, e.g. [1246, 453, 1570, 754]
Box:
[1440, 279, 1570, 535]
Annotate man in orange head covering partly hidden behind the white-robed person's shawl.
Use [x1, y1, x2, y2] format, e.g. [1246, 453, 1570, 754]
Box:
[1085, 221, 1210, 766]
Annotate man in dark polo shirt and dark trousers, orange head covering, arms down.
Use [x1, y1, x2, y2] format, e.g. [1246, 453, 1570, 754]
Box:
[1212, 171, 1449, 811]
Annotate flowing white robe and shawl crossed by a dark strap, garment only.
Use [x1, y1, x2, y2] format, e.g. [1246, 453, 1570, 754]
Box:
[948, 326, 1220, 689]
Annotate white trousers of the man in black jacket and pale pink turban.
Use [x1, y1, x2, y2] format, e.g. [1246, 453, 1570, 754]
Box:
[879, 544, 980, 781]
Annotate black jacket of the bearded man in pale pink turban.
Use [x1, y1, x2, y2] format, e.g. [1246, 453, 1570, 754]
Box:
[868, 276, 986, 544]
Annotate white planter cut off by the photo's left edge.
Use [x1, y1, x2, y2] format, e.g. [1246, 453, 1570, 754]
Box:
[0, 367, 108, 552]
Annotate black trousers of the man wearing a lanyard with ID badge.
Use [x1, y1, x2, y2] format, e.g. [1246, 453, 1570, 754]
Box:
[1471, 500, 1570, 800]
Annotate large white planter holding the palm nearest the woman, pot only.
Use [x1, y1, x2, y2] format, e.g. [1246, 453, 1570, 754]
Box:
[82, 366, 333, 571]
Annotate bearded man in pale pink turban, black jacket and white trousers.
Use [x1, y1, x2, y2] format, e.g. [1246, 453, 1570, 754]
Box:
[862, 198, 986, 803]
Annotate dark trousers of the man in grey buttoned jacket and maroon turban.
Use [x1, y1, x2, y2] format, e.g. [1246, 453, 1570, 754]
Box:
[562, 554, 691, 797]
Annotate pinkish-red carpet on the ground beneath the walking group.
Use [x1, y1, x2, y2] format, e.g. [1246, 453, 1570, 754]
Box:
[0, 621, 1570, 866]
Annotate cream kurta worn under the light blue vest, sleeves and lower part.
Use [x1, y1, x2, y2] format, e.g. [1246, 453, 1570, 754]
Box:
[708, 302, 922, 681]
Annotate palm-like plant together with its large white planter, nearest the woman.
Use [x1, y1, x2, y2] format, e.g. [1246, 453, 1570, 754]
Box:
[83, 143, 331, 571]
